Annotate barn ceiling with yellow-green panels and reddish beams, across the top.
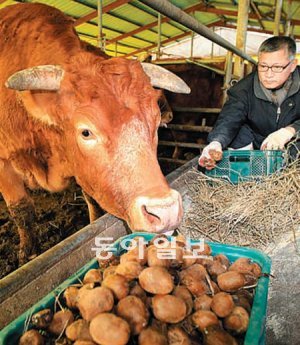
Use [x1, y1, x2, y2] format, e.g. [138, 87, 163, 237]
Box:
[0, 0, 300, 58]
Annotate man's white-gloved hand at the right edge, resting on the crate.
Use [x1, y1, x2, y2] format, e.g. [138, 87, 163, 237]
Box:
[260, 127, 296, 150]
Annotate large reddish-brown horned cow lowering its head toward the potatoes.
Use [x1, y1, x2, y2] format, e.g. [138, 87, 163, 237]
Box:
[0, 4, 190, 262]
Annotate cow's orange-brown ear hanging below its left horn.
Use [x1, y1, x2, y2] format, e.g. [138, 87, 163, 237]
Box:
[19, 91, 57, 126]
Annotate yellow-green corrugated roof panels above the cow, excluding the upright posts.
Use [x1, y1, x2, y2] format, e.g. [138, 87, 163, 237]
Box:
[0, 0, 300, 56]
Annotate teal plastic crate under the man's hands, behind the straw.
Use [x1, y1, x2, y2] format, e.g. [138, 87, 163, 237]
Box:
[205, 150, 284, 184]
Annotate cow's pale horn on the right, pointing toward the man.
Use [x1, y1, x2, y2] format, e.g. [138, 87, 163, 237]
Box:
[142, 62, 191, 93]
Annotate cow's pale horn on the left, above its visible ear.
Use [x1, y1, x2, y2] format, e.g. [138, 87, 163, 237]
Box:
[5, 65, 64, 91]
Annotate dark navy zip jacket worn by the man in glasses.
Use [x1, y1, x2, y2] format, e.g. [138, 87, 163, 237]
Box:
[208, 67, 300, 149]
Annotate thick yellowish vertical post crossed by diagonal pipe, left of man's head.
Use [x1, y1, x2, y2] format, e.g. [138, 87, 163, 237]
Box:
[233, 0, 250, 79]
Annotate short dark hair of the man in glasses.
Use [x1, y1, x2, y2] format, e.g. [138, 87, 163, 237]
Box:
[258, 36, 296, 60]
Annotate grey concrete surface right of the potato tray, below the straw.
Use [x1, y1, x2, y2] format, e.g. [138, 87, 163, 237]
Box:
[266, 228, 300, 345]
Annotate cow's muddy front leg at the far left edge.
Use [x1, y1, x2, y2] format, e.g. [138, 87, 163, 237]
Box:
[0, 160, 36, 265]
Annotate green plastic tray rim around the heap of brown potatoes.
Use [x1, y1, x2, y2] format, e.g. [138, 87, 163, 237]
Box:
[0, 233, 271, 345]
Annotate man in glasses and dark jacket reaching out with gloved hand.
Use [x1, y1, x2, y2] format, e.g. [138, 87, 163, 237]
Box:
[199, 36, 300, 170]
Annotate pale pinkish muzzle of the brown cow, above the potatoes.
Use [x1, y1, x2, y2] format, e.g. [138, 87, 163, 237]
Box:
[128, 189, 183, 233]
